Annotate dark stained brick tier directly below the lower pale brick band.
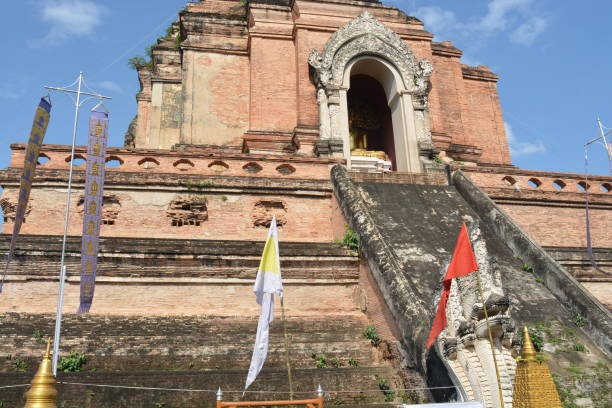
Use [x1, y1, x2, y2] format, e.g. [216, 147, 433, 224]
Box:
[0, 313, 379, 373]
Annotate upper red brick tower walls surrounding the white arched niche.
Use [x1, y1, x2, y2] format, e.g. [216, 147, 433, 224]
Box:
[128, 1, 510, 164]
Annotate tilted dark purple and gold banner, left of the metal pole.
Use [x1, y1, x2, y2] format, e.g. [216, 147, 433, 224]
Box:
[0, 98, 51, 293]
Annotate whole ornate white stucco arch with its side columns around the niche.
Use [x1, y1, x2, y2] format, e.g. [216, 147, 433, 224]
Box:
[308, 12, 436, 171]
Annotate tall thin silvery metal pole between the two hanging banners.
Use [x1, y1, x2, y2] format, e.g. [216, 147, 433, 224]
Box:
[53, 71, 83, 375]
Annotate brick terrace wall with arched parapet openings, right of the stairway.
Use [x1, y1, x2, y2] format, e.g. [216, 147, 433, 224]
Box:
[462, 167, 612, 307]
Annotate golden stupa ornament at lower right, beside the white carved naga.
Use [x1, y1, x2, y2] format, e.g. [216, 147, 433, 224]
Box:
[512, 327, 562, 408]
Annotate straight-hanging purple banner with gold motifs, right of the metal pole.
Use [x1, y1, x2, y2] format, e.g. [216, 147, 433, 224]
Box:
[77, 111, 108, 313]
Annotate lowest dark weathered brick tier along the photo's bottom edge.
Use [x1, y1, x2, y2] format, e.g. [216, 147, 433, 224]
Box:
[0, 367, 401, 408]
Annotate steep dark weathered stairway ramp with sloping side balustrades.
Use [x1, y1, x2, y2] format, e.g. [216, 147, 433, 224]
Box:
[332, 166, 612, 402]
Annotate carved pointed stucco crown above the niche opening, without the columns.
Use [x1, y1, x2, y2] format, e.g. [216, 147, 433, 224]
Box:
[308, 11, 433, 95]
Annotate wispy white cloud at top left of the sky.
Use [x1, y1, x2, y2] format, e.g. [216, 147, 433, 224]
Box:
[38, 0, 105, 45]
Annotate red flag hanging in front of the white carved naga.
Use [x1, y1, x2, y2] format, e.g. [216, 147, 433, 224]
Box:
[426, 224, 478, 349]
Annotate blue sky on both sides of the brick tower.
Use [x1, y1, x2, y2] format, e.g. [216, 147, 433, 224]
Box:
[0, 0, 612, 178]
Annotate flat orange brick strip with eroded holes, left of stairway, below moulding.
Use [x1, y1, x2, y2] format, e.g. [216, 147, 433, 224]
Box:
[2, 186, 338, 242]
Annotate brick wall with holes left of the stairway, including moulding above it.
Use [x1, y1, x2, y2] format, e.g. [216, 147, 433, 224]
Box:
[0, 164, 339, 242]
